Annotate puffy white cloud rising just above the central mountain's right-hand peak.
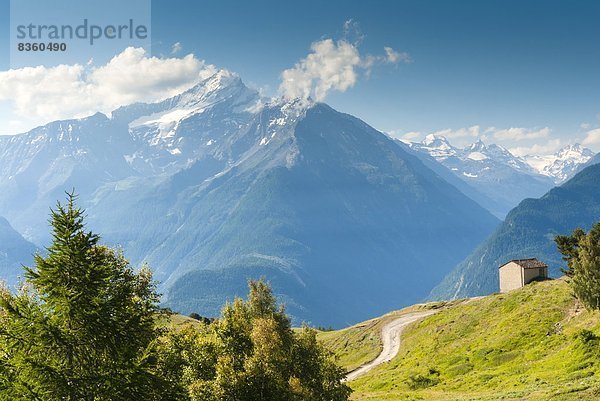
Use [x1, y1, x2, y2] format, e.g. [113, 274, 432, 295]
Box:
[279, 37, 410, 101]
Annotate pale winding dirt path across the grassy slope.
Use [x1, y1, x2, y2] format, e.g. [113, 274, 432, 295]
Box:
[345, 310, 439, 381]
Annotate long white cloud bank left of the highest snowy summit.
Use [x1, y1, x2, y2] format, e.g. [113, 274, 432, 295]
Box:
[0, 47, 216, 133]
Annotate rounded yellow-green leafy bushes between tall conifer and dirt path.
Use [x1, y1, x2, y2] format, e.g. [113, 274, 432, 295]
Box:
[159, 281, 351, 401]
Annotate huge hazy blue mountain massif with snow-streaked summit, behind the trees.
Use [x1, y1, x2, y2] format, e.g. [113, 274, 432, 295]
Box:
[0, 70, 499, 326]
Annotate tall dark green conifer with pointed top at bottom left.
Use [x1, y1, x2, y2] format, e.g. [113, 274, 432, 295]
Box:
[0, 193, 168, 401]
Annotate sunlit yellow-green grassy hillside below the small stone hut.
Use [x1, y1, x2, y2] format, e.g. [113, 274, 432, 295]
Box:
[322, 279, 600, 401]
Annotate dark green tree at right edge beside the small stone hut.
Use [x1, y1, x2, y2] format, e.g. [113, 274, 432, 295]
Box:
[556, 223, 600, 309]
